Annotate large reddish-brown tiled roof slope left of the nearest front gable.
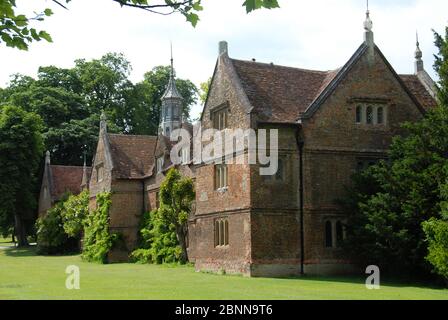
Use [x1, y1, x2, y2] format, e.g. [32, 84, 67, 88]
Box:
[232, 59, 339, 123]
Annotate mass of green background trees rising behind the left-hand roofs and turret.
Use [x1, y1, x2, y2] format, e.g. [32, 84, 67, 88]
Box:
[0, 53, 197, 165]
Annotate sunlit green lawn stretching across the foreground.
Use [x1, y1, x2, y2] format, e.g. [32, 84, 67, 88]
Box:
[0, 248, 448, 300]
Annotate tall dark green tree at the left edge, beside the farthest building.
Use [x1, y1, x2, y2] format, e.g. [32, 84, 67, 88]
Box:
[0, 106, 43, 246]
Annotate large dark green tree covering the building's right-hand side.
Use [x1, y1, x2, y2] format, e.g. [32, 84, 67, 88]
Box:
[343, 30, 448, 275]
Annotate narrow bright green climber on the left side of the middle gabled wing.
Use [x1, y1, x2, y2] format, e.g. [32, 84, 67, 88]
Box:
[82, 193, 119, 263]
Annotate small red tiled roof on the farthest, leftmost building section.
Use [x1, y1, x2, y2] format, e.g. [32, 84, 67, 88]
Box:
[50, 165, 92, 200]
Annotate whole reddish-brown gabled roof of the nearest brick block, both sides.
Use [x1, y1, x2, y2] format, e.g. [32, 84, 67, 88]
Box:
[226, 43, 436, 123]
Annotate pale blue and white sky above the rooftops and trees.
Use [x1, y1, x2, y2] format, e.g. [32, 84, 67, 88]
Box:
[0, 0, 448, 117]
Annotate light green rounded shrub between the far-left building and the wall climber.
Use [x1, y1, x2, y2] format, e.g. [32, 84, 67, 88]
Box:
[62, 190, 89, 239]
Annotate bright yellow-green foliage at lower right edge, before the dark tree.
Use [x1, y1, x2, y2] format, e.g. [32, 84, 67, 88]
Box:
[423, 218, 448, 281]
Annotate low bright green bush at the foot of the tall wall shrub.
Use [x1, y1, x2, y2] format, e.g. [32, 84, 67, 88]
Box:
[131, 210, 182, 264]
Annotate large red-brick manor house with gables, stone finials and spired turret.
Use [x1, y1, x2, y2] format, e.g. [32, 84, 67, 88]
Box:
[45, 12, 436, 276]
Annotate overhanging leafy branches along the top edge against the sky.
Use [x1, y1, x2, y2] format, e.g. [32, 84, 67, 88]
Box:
[0, 0, 279, 50]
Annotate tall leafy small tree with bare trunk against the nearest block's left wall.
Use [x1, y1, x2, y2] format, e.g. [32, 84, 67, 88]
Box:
[159, 169, 195, 263]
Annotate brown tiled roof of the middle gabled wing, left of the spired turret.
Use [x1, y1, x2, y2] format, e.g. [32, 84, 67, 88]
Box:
[109, 134, 157, 179]
